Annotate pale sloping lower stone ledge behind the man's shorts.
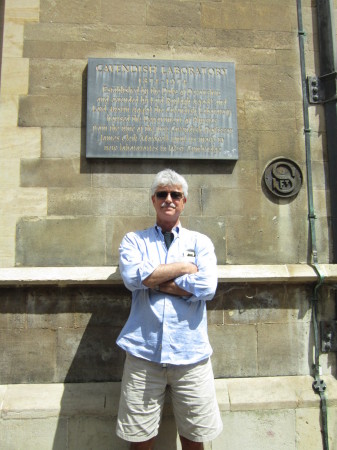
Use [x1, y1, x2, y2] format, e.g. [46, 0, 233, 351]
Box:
[0, 375, 337, 420]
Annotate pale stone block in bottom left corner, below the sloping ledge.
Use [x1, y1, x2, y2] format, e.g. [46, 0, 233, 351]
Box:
[0, 417, 69, 450]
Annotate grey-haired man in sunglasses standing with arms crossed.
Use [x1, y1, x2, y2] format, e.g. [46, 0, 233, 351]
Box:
[117, 169, 222, 450]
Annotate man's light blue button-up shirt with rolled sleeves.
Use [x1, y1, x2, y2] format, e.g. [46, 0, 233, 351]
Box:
[117, 225, 218, 365]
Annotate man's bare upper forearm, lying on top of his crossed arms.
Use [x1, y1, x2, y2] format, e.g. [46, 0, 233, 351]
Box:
[143, 262, 198, 289]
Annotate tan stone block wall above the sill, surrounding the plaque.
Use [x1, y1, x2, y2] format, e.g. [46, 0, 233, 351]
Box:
[0, 0, 330, 267]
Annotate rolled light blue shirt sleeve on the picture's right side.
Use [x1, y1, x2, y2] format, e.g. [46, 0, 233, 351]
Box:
[175, 234, 218, 302]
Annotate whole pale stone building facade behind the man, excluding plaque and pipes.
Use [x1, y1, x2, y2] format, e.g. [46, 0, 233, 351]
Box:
[0, 0, 337, 450]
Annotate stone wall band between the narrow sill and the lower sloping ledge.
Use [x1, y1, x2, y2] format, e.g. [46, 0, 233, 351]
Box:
[0, 283, 336, 384]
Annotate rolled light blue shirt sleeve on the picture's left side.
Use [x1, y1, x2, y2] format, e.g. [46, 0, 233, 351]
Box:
[119, 233, 155, 291]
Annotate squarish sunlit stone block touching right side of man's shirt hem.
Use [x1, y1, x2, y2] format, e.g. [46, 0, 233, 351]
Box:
[208, 325, 258, 378]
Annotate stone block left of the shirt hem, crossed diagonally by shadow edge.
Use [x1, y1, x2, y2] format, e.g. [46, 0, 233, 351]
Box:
[55, 322, 125, 383]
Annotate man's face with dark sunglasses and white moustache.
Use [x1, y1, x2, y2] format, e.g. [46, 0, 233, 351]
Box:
[152, 185, 186, 225]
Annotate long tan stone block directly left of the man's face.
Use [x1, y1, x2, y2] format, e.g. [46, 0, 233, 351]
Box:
[48, 188, 149, 216]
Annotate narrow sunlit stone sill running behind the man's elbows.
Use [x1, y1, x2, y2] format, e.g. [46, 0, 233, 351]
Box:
[0, 264, 337, 286]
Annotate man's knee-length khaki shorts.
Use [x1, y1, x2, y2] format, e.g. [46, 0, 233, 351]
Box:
[116, 353, 222, 442]
